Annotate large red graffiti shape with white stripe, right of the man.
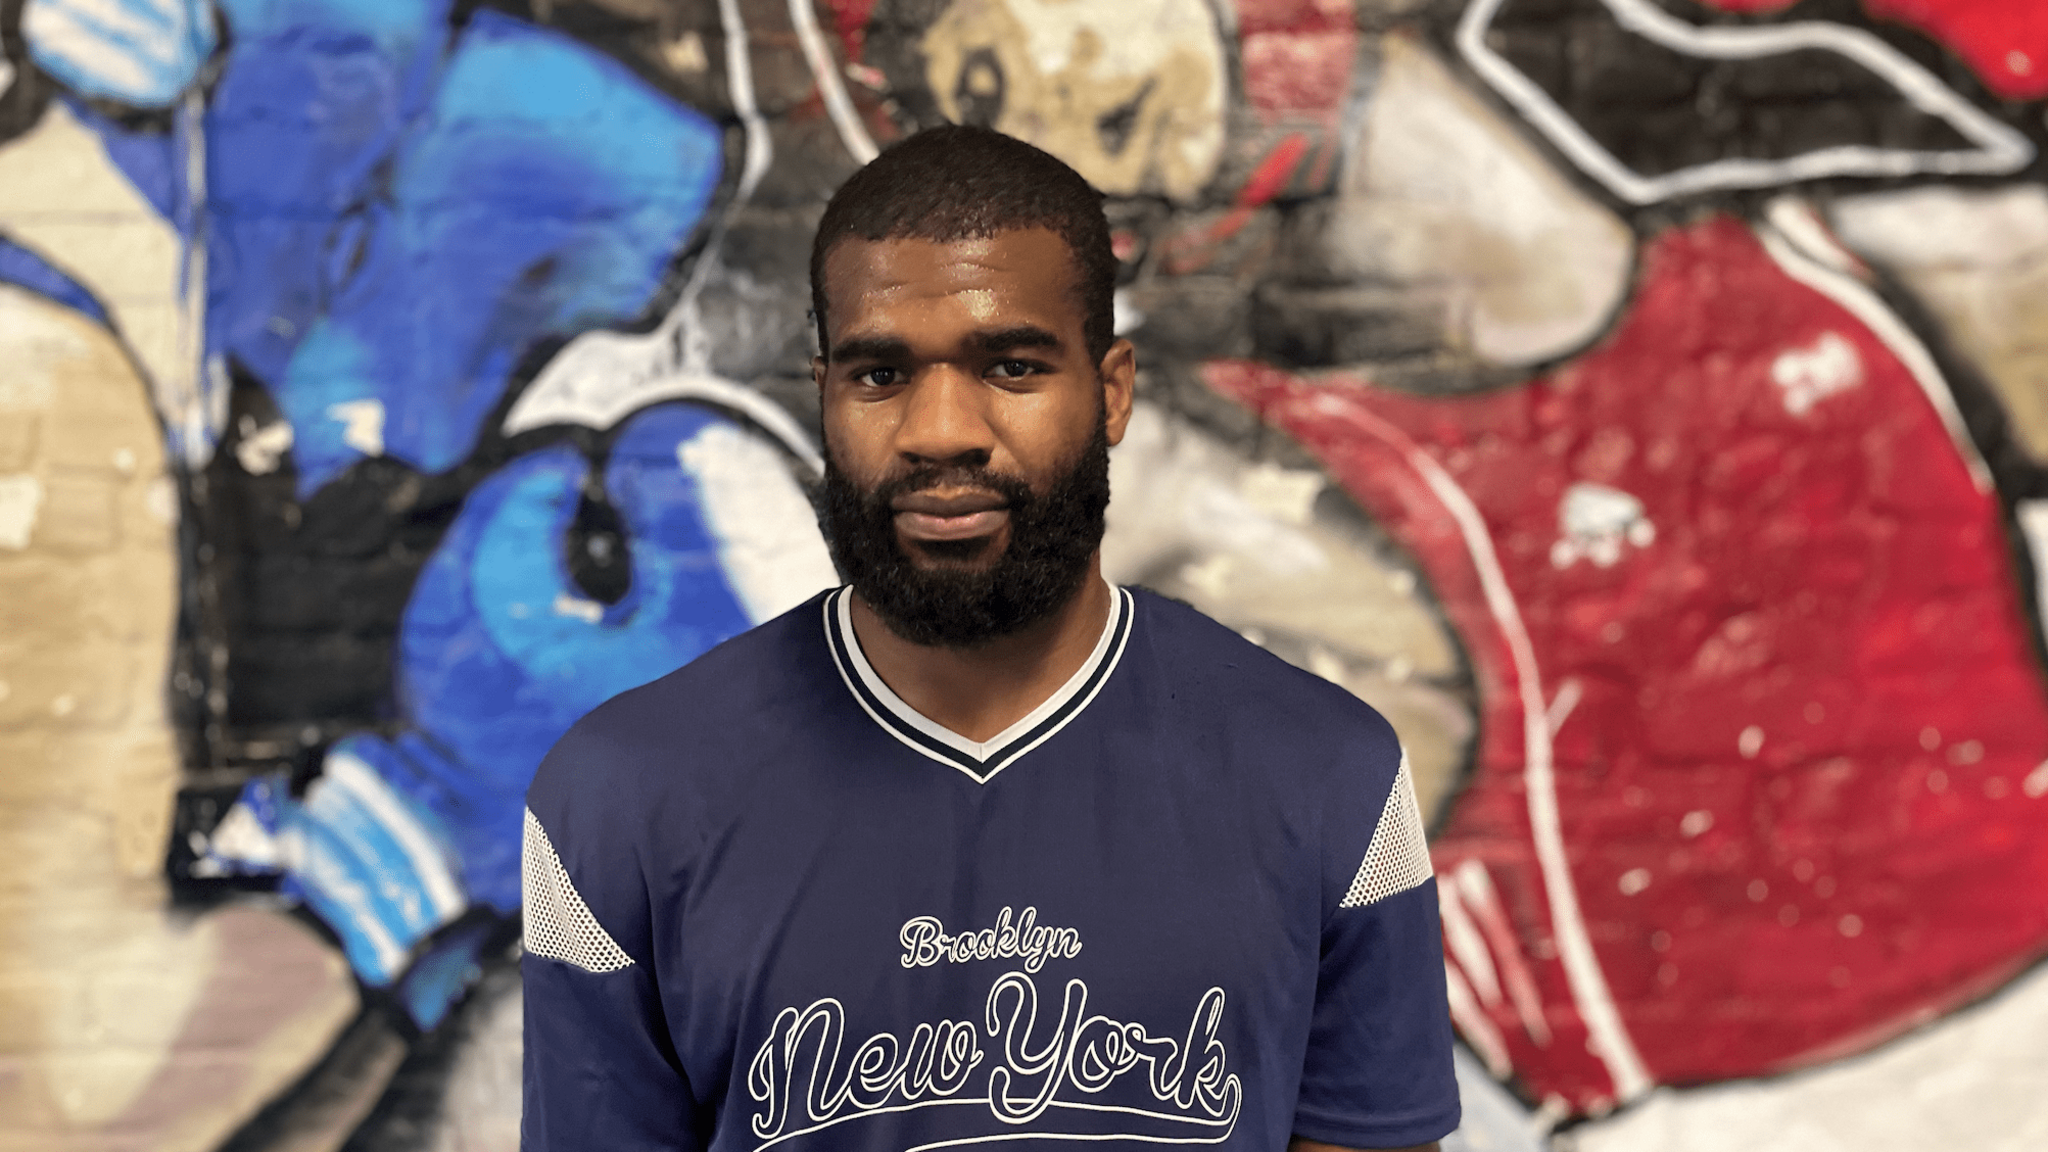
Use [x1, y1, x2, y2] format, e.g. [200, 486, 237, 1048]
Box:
[1206, 219, 2048, 1109]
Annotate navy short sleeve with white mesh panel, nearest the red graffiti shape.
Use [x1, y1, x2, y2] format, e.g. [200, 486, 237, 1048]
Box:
[1294, 734, 1460, 1148]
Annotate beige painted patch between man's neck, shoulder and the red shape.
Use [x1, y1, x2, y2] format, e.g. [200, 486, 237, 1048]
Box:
[1102, 404, 1477, 816]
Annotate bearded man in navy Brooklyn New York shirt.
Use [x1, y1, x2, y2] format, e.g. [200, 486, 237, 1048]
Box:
[524, 127, 1458, 1152]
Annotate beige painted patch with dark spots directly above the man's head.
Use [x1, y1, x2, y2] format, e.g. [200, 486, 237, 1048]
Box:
[924, 0, 1227, 201]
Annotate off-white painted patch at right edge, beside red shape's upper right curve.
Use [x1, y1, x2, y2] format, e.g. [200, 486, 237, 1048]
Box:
[1831, 184, 2048, 461]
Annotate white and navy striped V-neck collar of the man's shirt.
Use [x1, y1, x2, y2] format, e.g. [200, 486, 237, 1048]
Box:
[825, 586, 1137, 783]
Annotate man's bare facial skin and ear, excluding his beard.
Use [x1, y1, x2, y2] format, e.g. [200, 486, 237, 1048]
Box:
[811, 228, 1135, 566]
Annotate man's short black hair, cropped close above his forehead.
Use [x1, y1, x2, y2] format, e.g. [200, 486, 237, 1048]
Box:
[811, 125, 1116, 365]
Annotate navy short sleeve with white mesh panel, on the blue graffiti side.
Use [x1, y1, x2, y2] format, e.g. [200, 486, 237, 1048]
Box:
[520, 734, 705, 1152]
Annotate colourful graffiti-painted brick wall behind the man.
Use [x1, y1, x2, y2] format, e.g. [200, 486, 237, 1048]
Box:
[12, 0, 2048, 1152]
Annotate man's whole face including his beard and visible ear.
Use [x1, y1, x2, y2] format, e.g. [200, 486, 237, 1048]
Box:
[813, 230, 1135, 646]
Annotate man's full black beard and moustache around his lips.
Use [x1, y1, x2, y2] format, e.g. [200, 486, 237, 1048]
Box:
[823, 416, 1110, 648]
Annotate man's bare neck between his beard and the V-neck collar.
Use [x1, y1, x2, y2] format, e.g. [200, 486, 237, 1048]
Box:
[852, 556, 1112, 740]
